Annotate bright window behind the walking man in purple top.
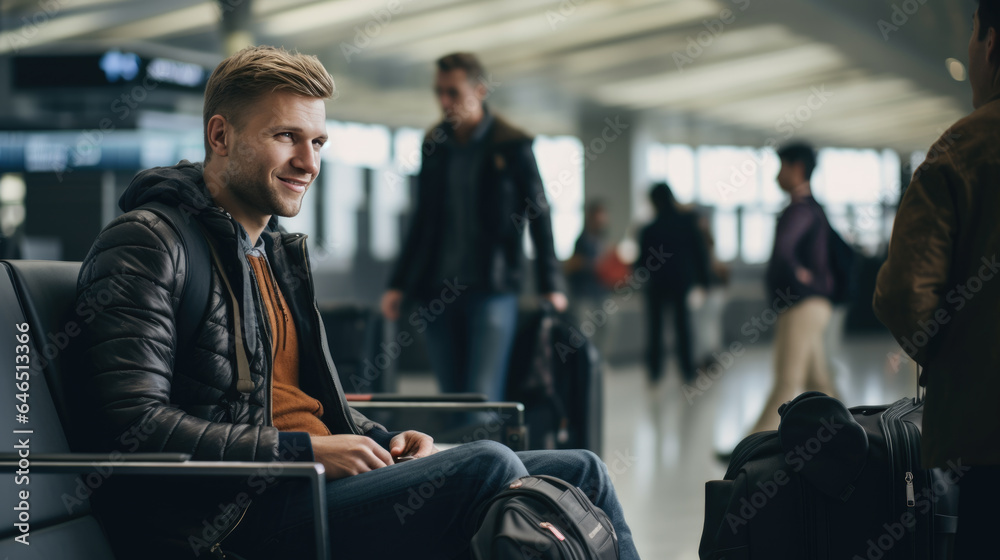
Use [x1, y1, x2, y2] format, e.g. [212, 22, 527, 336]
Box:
[633, 144, 904, 264]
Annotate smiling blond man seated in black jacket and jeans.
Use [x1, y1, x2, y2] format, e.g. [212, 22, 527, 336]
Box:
[78, 47, 638, 559]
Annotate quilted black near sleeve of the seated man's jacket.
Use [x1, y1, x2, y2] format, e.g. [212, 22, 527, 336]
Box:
[77, 211, 278, 461]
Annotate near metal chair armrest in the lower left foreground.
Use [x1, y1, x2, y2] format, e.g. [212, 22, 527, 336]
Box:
[0, 453, 329, 560]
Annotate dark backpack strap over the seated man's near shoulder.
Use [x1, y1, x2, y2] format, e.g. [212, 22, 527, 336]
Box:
[142, 202, 212, 358]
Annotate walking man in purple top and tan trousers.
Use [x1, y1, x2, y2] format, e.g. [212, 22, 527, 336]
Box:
[753, 143, 836, 432]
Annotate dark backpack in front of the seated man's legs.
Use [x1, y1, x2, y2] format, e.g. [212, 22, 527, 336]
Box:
[471, 476, 619, 560]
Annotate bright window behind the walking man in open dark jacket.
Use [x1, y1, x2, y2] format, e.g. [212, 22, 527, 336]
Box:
[292, 121, 583, 269]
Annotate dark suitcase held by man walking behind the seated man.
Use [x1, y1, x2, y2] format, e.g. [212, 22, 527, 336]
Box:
[506, 305, 604, 454]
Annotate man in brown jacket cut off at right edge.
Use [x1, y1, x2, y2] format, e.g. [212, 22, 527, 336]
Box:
[874, 0, 1000, 558]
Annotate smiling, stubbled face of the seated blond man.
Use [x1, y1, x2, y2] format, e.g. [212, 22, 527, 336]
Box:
[224, 91, 327, 227]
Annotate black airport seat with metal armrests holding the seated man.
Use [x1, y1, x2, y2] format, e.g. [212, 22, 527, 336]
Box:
[0, 260, 526, 560]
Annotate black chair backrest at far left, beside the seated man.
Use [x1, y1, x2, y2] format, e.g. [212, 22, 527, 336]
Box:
[0, 260, 115, 558]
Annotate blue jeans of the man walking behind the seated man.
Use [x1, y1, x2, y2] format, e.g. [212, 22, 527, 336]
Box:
[426, 291, 517, 401]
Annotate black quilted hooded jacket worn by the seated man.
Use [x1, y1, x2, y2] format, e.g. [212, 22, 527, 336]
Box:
[77, 162, 386, 461]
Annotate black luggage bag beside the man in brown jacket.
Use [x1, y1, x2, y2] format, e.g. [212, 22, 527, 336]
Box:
[699, 392, 965, 560]
